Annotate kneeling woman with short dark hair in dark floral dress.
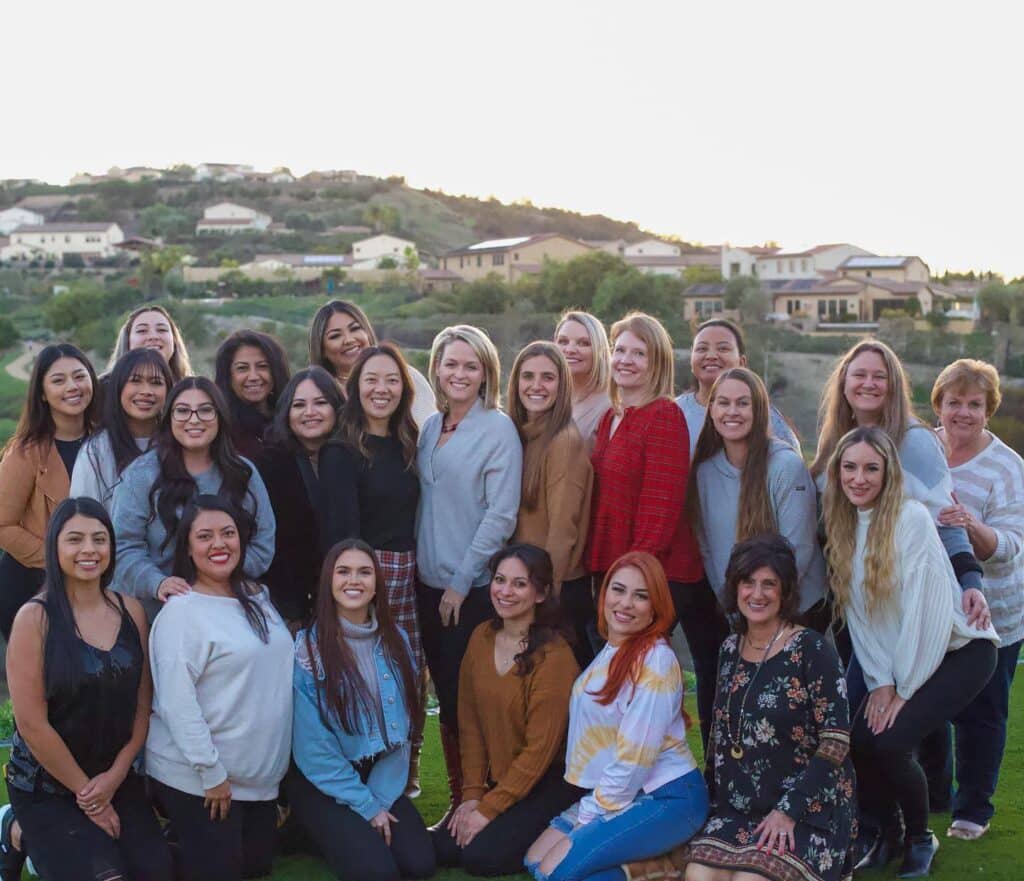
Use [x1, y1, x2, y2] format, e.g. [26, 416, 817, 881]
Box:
[686, 535, 856, 881]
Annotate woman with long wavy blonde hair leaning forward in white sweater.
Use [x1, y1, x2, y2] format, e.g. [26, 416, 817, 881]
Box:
[824, 426, 998, 878]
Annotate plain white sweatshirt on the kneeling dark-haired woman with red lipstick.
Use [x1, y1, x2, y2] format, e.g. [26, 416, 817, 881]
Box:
[145, 589, 293, 801]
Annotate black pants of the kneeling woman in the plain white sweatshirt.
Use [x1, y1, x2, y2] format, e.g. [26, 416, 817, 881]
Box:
[149, 778, 278, 881]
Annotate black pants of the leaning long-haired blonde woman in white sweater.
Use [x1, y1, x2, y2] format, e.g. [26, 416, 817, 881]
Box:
[847, 639, 996, 835]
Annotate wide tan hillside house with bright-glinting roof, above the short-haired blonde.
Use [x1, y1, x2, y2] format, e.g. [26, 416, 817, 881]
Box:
[439, 233, 594, 282]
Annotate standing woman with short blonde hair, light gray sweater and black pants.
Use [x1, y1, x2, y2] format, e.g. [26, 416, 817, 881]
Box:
[416, 325, 522, 827]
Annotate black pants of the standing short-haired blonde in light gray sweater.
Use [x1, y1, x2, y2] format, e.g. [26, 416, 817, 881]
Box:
[416, 579, 494, 725]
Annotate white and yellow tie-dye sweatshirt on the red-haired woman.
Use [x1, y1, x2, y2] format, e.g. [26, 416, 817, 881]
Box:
[565, 640, 696, 824]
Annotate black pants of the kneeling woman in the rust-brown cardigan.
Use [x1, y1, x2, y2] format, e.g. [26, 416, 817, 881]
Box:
[431, 761, 587, 877]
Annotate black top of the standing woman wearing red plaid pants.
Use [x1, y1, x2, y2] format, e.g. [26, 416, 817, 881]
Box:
[319, 434, 420, 551]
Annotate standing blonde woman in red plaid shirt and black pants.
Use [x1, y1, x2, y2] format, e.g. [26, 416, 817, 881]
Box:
[585, 312, 725, 745]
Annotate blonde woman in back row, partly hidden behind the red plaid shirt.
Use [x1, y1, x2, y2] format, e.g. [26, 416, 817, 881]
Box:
[555, 309, 611, 450]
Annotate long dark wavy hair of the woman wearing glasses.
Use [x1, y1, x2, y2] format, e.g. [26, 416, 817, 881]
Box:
[150, 376, 255, 547]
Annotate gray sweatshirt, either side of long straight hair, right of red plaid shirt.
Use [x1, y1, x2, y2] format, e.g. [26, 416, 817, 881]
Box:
[695, 441, 825, 612]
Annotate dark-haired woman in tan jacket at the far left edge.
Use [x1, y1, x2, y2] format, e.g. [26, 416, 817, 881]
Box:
[0, 343, 99, 639]
